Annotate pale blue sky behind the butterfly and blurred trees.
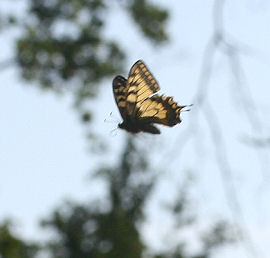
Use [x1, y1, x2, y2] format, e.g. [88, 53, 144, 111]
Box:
[0, 0, 270, 258]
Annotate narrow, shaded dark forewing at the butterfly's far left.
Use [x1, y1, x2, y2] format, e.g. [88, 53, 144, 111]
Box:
[113, 75, 127, 120]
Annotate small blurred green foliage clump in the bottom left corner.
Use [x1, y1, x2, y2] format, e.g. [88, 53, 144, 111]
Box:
[0, 222, 39, 258]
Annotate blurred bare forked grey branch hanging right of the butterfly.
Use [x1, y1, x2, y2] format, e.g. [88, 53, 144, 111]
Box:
[167, 0, 262, 257]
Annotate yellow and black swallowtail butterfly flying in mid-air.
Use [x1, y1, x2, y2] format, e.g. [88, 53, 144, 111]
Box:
[113, 60, 185, 134]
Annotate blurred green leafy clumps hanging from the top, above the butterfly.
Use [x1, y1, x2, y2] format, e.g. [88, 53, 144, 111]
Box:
[16, 0, 168, 110]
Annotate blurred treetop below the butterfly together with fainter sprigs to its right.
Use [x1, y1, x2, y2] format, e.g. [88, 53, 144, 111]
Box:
[42, 137, 231, 258]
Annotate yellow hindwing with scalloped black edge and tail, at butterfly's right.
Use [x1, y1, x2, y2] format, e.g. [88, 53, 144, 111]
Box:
[138, 95, 184, 126]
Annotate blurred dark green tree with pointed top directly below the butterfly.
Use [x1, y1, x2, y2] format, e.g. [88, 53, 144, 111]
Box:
[43, 139, 153, 258]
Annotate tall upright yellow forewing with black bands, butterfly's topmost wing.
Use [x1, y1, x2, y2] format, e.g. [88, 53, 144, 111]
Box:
[126, 60, 160, 117]
